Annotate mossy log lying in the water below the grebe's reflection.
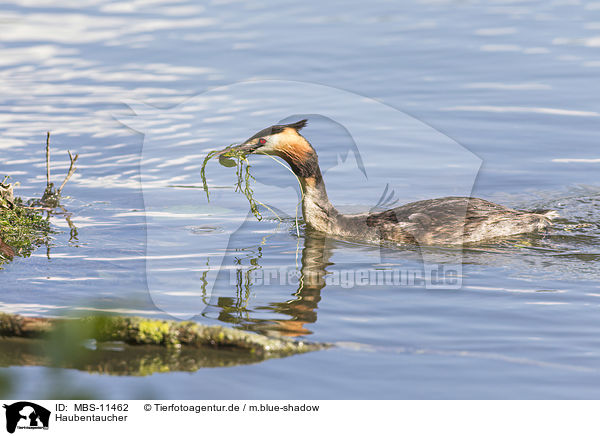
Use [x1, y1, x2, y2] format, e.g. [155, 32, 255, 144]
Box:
[0, 313, 330, 357]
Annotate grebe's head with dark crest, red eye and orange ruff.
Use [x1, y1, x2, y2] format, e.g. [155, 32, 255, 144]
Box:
[224, 120, 320, 178]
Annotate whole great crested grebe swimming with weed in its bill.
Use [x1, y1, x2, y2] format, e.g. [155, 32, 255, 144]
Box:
[221, 120, 553, 245]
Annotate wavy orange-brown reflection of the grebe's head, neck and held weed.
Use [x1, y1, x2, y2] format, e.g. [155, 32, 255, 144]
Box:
[211, 229, 334, 336]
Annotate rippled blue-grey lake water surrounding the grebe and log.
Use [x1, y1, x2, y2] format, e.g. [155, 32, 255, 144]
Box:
[0, 0, 600, 398]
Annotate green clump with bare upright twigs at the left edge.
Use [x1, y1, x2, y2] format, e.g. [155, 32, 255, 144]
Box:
[0, 132, 79, 265]
